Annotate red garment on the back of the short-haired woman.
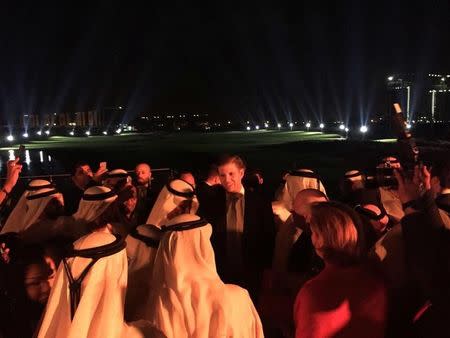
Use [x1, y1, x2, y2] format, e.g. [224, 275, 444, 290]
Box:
[294, 264, 387, 338]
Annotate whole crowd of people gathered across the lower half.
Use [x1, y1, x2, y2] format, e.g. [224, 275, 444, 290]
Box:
[0, 155, 450, 338]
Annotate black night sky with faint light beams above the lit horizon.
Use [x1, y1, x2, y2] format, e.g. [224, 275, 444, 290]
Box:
[0, 0, 450, 120]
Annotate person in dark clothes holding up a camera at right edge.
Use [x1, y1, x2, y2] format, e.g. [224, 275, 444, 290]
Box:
[395, 166, 450, 337]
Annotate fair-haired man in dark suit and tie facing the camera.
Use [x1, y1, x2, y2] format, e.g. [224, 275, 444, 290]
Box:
[199, 155, 275, 297]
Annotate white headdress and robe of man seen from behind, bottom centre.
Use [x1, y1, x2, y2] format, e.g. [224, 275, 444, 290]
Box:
[148, 214, 264, 338]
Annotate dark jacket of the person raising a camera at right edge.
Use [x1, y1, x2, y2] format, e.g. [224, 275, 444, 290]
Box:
[401, 192, 450, 337]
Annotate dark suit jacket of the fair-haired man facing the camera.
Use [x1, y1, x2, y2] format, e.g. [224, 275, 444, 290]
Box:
[198, 186, 275, 282]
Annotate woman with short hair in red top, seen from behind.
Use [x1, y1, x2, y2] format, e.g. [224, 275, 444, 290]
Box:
[294, 202, 387, 338]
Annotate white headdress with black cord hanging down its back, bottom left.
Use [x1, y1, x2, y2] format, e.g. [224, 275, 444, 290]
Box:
[38, 232, 153, 338]
